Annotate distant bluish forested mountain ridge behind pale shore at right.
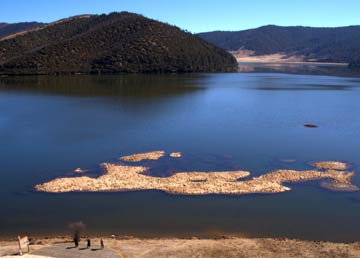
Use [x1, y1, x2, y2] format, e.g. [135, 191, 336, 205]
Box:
[198, 25, 360, 63]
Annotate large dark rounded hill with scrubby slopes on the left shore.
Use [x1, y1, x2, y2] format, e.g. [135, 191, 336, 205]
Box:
[0, 12, 237, 74]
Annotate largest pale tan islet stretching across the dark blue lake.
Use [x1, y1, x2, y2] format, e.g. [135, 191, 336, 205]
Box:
[35, 159, 358, 195]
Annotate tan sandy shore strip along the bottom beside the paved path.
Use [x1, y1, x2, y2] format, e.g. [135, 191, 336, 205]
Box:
[0, 236, 360, 258]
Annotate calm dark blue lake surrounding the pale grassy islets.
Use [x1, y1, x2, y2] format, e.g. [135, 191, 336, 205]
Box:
[0, 64, 360, 241]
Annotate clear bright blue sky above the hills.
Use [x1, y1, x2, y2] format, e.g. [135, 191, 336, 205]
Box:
[0, 0, 360, 32]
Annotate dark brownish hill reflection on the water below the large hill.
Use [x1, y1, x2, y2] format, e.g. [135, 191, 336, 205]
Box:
[0, 74, 204, 98]
